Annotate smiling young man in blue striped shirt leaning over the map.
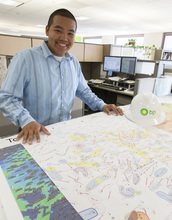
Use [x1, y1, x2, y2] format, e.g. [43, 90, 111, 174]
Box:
[0, 9, 123, 144]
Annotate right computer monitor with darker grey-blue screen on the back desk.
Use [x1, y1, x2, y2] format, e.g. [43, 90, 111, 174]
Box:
[121, 57, 137, 75]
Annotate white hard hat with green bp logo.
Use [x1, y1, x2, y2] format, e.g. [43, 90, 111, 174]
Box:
[124, 92, 166, 125]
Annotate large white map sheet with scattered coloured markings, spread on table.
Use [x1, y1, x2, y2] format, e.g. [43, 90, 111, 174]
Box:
[0, 105, 172, 220]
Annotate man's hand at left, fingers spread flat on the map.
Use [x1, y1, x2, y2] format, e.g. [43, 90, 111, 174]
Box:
[16, 121, 50, 144]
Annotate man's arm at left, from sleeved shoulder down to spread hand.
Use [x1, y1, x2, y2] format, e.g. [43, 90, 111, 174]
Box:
[0, 55, 49, 144]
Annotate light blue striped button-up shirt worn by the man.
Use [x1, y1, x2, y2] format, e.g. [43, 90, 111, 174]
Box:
[0, 42, 105, 128]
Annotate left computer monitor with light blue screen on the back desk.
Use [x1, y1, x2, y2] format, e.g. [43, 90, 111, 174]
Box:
[103, 56, 121, 76]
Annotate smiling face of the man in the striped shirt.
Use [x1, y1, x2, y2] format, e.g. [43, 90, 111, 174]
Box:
[46, 15, 76, 57]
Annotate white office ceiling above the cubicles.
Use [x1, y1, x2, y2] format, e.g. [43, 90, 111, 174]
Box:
[0, 0, 172, 37]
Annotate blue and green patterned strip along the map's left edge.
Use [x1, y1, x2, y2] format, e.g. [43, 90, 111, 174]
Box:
[0, 144, 83, 220]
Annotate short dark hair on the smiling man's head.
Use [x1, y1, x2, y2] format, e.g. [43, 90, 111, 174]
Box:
[47, 8, 77, 31]
